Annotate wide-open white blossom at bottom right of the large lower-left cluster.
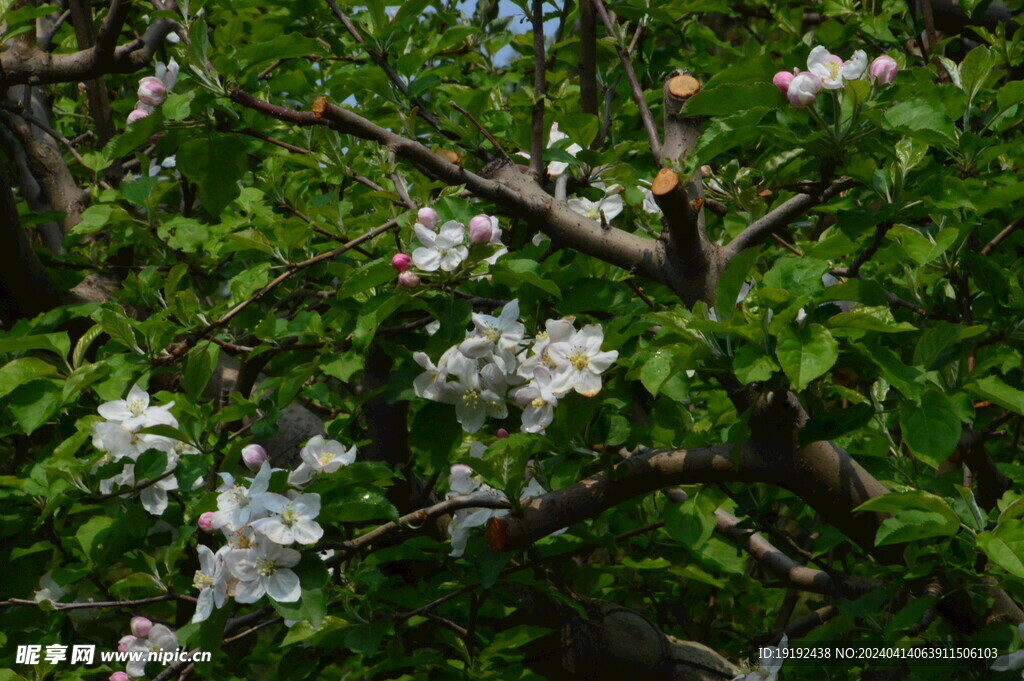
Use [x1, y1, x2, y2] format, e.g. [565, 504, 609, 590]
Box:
[224, 538, 302, 603]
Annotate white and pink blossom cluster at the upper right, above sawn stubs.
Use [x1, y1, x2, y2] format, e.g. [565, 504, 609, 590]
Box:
[772, 45, 898, 107]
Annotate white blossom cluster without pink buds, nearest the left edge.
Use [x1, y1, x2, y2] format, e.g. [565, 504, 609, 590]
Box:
[92, 385, 198, 515]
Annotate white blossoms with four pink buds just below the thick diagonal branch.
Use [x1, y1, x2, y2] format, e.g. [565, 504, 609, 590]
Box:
[391, 207, 508, 289]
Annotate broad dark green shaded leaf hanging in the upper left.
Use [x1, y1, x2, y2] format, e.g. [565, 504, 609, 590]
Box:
[176, 134, 249, 218]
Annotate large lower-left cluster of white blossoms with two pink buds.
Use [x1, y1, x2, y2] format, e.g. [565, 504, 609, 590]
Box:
[193, 435, 356, 622]
